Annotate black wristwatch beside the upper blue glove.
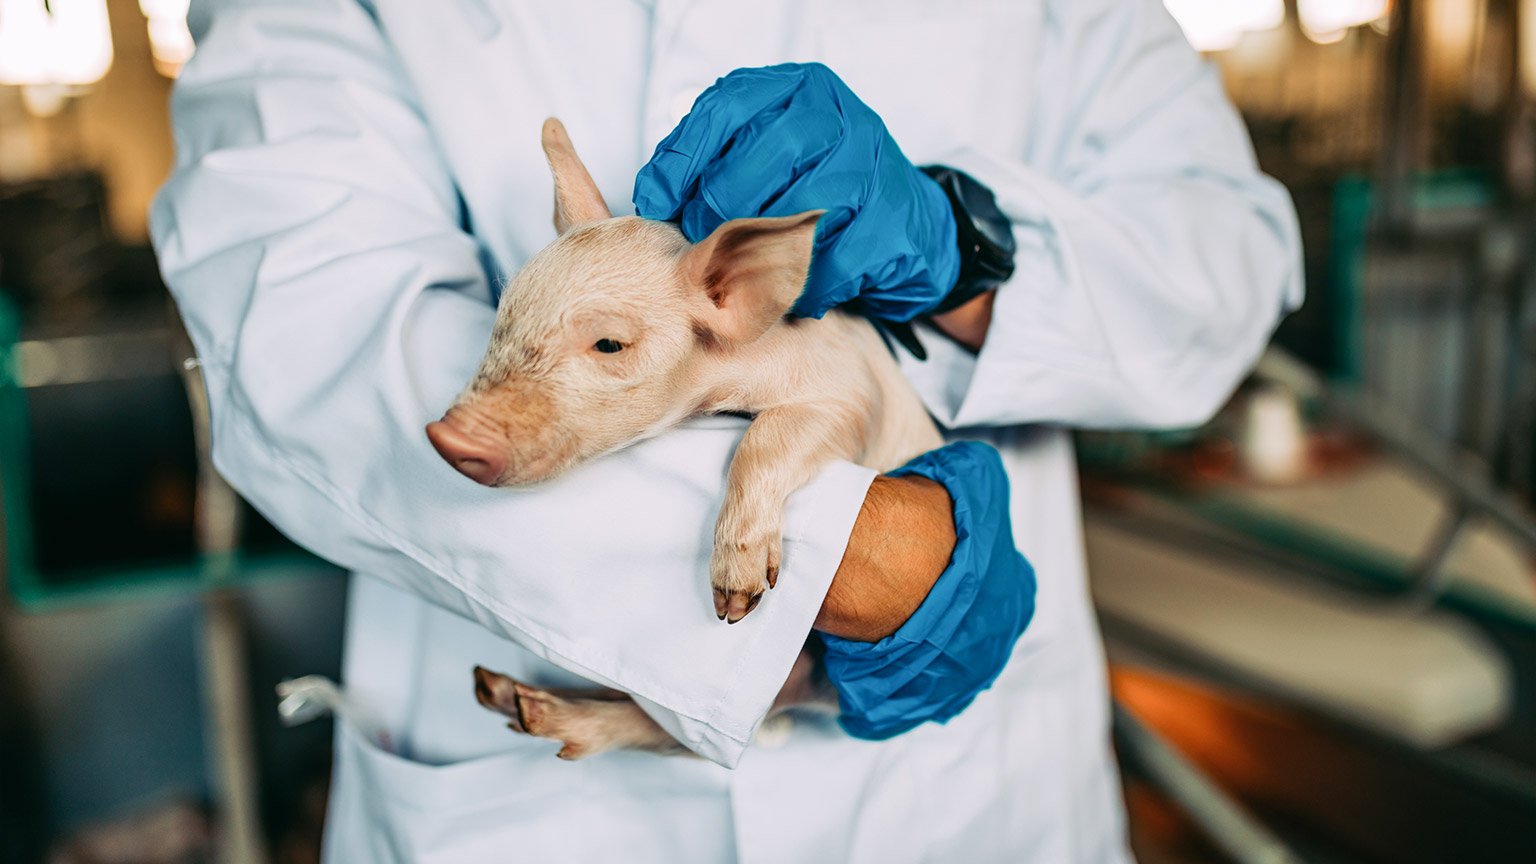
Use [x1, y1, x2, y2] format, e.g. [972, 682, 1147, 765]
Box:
[879, 164, 1017, 360]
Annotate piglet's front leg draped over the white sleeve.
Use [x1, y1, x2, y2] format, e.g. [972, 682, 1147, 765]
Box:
[710, 404, 866, 624]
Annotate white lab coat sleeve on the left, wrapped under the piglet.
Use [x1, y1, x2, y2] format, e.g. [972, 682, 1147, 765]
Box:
[152, 0, 872, 766]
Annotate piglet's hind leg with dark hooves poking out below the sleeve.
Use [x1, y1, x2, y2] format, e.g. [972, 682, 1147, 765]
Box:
[475, 666, 688, 759]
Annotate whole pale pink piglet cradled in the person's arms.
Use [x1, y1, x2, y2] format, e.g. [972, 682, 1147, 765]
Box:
[427, 118, 943, 758]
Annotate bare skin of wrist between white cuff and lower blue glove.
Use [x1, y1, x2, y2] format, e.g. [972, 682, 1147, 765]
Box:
[816, 475, 955, 643]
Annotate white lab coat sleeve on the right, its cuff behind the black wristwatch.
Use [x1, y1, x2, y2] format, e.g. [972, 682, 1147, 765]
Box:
[902, 0, 1303, 427]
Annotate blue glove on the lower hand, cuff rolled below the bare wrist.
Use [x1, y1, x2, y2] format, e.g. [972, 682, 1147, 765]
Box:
[822, 441, 1035, 741]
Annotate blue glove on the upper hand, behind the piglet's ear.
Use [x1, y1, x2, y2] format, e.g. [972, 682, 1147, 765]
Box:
[634, 63, 960, 321]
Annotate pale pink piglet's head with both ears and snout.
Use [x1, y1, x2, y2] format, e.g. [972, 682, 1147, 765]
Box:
[427, 120, 822, 486]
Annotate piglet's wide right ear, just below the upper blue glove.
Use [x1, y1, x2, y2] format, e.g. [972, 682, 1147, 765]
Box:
[682, 211, 826, 344]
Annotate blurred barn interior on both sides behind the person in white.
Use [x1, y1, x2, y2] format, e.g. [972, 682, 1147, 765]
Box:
[0, 0, 1536, 864]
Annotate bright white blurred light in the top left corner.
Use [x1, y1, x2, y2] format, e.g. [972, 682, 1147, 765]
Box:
[0, 0, 112, 85]
